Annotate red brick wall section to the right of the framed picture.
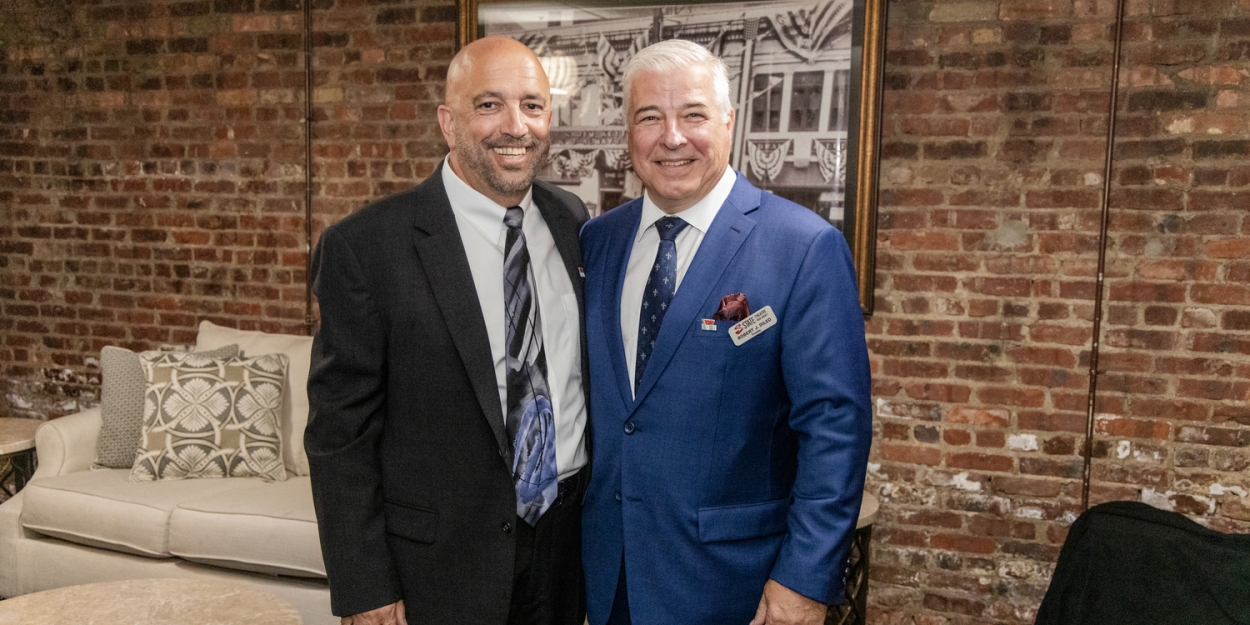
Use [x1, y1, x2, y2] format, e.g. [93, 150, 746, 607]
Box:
[869, 0, 1250, 625]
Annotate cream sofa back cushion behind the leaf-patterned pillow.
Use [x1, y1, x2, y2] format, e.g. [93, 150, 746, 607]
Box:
[195, 321, 313, 475]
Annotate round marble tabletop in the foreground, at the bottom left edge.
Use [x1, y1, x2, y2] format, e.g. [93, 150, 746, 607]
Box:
[0, 579, 304, 625]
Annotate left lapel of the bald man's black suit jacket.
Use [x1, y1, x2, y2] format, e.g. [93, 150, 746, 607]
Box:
[413, 165, 513, 465]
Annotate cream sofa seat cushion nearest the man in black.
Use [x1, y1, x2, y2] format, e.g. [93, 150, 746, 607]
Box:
[169, 478, 325, 578]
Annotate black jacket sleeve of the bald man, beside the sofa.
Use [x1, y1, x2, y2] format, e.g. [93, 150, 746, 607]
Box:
[304, 228, 403, 616]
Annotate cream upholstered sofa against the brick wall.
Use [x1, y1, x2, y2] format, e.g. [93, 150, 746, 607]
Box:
[0, 323, 339, 625]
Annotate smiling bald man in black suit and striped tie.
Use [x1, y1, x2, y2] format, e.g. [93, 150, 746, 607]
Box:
[305, 38, 589, 625]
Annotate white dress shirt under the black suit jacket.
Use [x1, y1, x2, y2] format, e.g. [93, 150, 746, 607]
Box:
[443, 159, 590, 480]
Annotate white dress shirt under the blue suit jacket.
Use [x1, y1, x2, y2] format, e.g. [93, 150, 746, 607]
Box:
[621, 166, 738, 393]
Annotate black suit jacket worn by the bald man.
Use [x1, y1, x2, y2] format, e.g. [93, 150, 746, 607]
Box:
[305, 168, 589, 625]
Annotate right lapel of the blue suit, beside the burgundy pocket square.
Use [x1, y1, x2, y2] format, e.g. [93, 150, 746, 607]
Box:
[630, 174, 760, 413]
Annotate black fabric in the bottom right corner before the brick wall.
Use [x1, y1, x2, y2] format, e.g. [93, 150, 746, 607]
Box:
[1036, 501, 1250, 625]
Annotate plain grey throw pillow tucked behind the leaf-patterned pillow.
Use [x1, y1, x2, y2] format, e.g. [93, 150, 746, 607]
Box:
[91, 345, 239, 469]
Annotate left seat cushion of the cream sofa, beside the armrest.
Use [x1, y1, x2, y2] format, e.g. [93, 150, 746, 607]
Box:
[21, 469, 252, 558]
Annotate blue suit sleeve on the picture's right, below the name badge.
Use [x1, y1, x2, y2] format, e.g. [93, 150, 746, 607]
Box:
[770, 229, 873, 604]
